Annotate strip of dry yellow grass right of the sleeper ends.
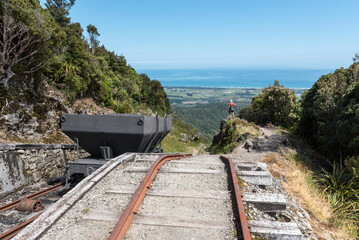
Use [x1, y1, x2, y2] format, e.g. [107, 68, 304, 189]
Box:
[262, 150, 353, 240]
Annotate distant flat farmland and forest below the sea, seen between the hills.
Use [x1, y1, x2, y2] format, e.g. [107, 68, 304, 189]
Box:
[164, 87, 305, 140]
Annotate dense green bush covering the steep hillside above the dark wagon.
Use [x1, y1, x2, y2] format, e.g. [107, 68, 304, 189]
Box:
[0, 0, 170, 114]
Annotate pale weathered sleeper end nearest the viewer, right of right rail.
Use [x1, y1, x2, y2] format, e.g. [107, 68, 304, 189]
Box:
[248, 221, 302, 240]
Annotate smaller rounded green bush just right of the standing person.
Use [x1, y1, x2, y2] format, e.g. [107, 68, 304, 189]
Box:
[239, 81, 298, 128]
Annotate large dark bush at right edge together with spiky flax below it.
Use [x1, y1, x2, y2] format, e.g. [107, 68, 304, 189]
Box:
[295, 62, 359, 232]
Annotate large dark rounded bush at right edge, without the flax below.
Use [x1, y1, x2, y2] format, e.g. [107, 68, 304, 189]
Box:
[296, 63, 359, 162]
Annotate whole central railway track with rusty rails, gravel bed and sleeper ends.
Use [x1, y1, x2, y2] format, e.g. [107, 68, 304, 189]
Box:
[14, 154, 308, 240]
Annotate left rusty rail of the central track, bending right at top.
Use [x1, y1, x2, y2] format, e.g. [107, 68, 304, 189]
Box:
[108, 154, 191, 240]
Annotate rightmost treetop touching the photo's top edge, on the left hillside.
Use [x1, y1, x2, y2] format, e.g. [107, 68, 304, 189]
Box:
[45, 0, 75, 28]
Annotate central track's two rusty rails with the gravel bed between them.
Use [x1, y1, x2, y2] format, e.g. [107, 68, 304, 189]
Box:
[108, 156, 250, 240]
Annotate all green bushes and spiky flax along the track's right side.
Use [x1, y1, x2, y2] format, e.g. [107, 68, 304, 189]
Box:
[236, 61, 359, 238]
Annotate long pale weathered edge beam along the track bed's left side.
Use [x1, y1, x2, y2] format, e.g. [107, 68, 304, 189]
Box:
[12, 153, 136, 240]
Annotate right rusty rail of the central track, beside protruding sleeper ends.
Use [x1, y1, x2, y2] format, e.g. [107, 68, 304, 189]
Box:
[221, 155, 251, 240]
